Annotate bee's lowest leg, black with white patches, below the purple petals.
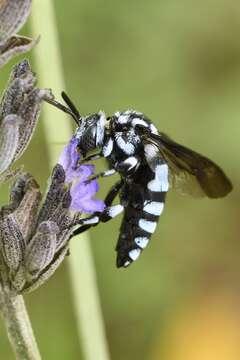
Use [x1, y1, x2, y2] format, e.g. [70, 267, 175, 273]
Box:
[71, 180, 123, 238]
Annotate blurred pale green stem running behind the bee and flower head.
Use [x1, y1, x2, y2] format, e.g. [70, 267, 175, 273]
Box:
[31, 0, 109, 360]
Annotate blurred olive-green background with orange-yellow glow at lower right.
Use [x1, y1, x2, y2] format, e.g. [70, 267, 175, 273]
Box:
[0, 0, 240, 360]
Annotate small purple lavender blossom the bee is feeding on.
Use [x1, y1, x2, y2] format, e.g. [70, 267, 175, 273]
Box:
[59, 137, 105, 214]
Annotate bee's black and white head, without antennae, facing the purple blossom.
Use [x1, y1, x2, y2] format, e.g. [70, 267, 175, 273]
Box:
[76, 111, 106, 156]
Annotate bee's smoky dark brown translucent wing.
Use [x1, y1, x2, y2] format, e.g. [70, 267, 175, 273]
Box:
[148, 133, 232, 198]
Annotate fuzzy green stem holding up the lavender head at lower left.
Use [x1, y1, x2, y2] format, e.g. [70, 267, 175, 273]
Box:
[0, 287, 41, 360]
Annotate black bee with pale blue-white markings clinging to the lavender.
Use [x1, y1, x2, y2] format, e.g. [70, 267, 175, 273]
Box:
[48, 93, 232, 267]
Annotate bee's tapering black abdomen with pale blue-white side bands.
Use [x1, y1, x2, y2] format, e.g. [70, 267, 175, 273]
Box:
[116, 166, 166, 267]
